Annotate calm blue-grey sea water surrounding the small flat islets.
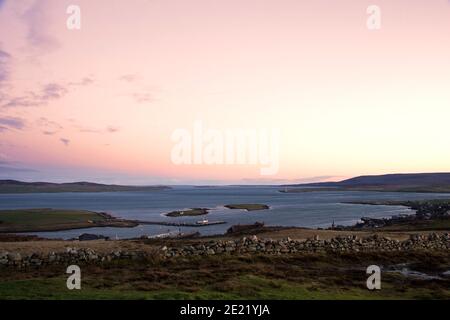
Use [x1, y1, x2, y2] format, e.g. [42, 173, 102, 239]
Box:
[0, 186, 450, 239]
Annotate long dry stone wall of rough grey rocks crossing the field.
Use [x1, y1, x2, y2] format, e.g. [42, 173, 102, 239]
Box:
[0, 233, 450, 268]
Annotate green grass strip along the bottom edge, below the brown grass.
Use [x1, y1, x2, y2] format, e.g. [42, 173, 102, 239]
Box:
[0, 276, 410, 300]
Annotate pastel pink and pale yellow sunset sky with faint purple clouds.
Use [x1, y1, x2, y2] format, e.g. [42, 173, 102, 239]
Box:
[0, 0, 450, 184]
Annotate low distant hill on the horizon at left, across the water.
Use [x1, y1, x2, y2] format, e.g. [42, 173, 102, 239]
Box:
[0, 180, 170, 193]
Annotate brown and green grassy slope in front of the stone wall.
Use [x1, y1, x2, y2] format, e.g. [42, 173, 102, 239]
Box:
[0, 252, 450, 299]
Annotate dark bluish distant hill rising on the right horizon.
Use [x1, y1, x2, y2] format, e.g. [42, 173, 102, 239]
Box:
[288, 173, 450, 192]
